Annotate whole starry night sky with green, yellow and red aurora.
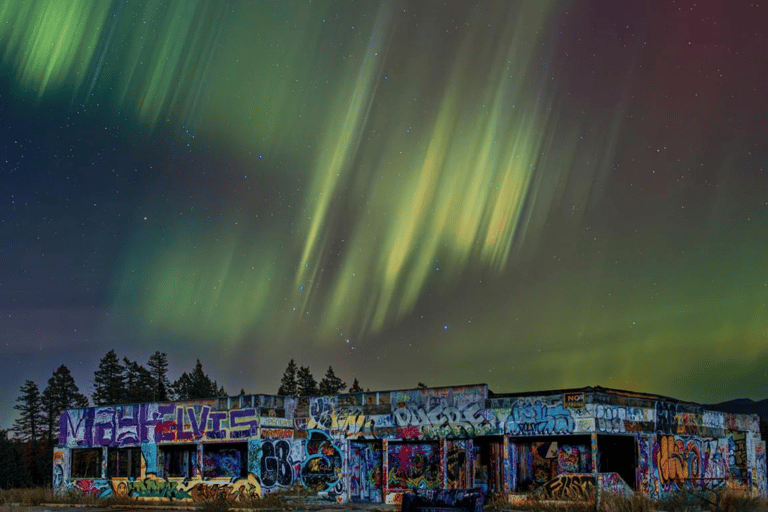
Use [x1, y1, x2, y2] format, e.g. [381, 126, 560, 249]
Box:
[0, 0, 768, 428]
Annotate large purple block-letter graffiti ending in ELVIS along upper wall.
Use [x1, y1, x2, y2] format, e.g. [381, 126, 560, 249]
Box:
[59, 404, 259, 447]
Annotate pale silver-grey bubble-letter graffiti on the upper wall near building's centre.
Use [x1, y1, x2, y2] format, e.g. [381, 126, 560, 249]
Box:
[393, 404, 498, 438]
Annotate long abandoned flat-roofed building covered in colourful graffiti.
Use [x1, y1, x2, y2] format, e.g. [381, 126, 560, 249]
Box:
[53, 384, 766, 503]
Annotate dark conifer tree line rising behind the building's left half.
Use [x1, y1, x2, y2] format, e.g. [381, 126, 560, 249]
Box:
[5, 350, 363, 489]
